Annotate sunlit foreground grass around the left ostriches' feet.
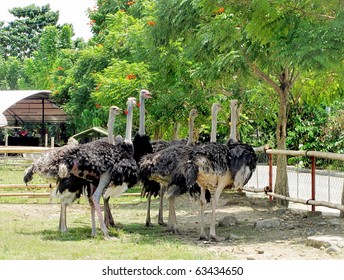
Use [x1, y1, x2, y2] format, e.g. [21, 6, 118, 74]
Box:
[0, 202, 234, 260]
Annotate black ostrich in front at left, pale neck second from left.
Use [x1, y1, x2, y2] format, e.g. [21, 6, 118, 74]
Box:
[58, 97, 138, 239]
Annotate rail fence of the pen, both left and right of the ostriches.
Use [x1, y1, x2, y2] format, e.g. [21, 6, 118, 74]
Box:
[0, 146, 344, 212]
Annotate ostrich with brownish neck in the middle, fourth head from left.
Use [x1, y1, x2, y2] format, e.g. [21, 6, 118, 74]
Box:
[139, 109, 198, 232]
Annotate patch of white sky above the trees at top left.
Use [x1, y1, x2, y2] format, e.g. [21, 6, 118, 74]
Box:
[0, 0, 96, 40]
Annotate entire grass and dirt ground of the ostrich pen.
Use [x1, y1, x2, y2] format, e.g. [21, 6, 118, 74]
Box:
[0, 148, 344, 259]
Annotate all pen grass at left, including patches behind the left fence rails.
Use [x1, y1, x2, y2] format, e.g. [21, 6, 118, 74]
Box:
[0, 166, 236, 260]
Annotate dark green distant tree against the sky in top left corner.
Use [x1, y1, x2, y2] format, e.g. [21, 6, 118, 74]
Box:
[0, 4, 59, 59]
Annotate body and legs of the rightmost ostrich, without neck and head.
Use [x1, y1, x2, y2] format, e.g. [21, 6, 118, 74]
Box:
[169, 141, 257, 241]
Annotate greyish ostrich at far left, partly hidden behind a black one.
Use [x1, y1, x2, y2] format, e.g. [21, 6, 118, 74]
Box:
[24, 106, 122, 232]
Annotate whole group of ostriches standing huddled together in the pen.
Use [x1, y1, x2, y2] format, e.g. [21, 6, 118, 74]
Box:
[24, 90, 257, 241]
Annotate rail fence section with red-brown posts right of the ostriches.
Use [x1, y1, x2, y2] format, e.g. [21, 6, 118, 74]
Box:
[245, 150, 344, 215]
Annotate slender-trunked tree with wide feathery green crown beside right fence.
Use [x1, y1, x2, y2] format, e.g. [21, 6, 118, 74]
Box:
[166, 0, 343, 204]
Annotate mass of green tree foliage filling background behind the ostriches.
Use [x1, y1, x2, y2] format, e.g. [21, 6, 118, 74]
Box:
[0, 0, 344, 151]
